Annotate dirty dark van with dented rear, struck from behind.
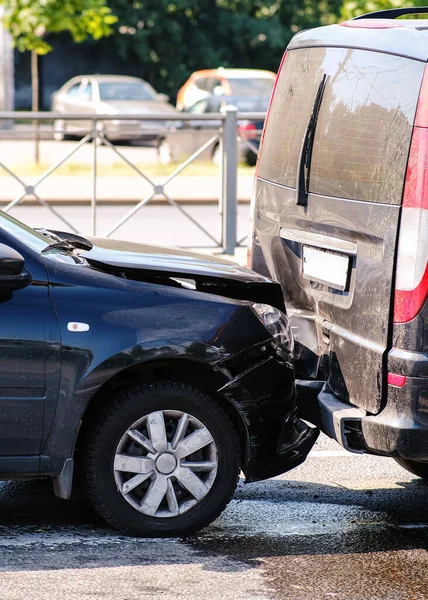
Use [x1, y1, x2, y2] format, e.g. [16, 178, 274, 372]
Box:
[249, 7, 428, 478]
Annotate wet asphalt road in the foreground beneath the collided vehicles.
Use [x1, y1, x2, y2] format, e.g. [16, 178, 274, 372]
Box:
[0, 438, 428, 600]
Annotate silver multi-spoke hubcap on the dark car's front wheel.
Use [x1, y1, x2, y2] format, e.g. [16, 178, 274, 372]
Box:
[113, 410, 218, 517]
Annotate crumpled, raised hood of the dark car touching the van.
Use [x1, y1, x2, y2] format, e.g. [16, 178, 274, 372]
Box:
[79, 238, 284, 310]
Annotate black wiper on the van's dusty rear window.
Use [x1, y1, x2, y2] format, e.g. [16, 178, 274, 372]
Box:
[296, 74, 328, 206]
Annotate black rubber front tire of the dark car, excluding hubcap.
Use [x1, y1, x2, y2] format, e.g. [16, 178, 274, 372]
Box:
[82, 381, 240, 537]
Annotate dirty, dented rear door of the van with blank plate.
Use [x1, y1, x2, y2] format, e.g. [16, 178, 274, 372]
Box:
[252, 39, 425, 413]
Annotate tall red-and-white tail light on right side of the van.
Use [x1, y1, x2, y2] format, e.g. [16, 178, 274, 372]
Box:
[394, 67, 428, 323]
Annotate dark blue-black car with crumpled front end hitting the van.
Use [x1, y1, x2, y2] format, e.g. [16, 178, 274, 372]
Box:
[0, 212, 318, 535]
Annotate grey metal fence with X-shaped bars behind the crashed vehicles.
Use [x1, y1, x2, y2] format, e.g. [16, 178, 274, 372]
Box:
[0, 106, 265, 254]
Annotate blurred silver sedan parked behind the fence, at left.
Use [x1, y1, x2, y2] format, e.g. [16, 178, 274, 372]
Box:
[52, 75, 176, 141]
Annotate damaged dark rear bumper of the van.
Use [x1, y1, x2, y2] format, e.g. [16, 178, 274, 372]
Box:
[297, 377, 428, 461]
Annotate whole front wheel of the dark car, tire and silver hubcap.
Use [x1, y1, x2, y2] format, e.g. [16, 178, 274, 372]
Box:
[84, 381, 240, 537]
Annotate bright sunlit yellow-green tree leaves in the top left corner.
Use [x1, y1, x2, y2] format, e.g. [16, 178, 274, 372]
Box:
[0, 0, 117, 54]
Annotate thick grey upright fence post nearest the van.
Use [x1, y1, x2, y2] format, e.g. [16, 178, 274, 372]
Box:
[222, 106, 238, 254]
